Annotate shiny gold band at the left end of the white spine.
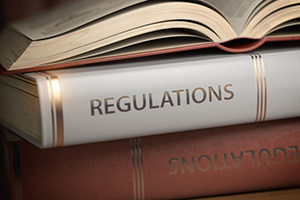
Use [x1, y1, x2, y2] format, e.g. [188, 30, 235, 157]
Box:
[39, 72, 64, 147]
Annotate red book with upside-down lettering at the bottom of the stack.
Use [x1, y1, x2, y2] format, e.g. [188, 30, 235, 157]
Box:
[2, 118, 300, 200]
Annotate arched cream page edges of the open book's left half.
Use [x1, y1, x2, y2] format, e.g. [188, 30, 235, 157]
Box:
[5, 1, 236, 69]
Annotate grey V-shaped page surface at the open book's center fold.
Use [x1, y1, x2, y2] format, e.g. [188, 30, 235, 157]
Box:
[206, 0, 262, 35]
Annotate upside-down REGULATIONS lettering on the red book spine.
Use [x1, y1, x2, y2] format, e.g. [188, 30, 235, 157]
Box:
[168, 146, 299, 175]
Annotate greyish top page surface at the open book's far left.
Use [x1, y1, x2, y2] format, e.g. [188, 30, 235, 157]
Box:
[13, 0, 146, 40]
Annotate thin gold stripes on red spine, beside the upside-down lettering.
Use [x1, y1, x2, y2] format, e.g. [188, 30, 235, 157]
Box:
[130, 138, 145, 200]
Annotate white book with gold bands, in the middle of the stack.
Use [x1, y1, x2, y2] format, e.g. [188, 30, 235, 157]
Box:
[0, 47, 300, 148]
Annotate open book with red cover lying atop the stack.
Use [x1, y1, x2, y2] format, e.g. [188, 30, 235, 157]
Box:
[0, 0, 300, 73]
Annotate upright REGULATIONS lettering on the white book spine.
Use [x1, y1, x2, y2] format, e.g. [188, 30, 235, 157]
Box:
[90, 84, 234, 116]
